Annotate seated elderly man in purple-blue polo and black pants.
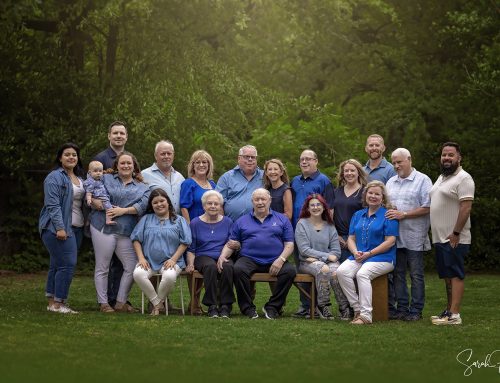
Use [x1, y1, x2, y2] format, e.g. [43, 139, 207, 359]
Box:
[217, 188, 296, 319]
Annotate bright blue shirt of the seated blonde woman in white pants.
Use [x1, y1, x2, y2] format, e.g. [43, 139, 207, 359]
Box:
[349, 207, 399, 264]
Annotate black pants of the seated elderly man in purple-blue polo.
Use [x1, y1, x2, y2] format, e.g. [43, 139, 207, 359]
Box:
[234, 257, 297, 314]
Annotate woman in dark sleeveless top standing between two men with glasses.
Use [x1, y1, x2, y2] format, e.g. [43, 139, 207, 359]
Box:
[262, 158, 293, 220]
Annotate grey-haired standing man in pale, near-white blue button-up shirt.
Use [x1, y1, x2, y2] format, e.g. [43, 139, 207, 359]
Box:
[141, 140, 184, 214]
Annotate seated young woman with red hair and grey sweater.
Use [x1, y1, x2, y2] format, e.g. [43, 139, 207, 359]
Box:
[295, 194, 341, 319]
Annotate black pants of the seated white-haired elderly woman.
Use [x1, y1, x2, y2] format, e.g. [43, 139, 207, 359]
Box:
[194, 255, 234, 306]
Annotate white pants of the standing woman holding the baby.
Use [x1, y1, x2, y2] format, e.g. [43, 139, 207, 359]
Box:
[90, 225, 137, 303]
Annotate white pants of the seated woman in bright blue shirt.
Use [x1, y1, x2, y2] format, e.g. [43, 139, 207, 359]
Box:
[337, 259, 394, 322]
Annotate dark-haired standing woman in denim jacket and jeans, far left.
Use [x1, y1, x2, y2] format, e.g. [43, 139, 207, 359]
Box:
[38, 143, 84, 314]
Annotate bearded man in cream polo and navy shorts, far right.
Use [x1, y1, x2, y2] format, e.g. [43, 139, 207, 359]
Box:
[430, 142, 475, 325]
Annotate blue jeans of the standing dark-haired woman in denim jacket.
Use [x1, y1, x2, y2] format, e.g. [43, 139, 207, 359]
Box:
[42, 230, 78, 302]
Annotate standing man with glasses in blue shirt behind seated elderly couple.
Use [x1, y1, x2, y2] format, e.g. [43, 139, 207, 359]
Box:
[215, 145, 264, 222]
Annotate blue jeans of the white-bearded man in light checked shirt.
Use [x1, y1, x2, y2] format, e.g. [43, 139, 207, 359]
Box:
[394, 248, 425, 315]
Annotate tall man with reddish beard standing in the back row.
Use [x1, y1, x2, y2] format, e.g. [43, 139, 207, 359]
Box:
[364, 134, 396, 184]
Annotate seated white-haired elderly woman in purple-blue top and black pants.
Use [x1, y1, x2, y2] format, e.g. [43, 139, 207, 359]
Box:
[186, 190, 234, 318]
